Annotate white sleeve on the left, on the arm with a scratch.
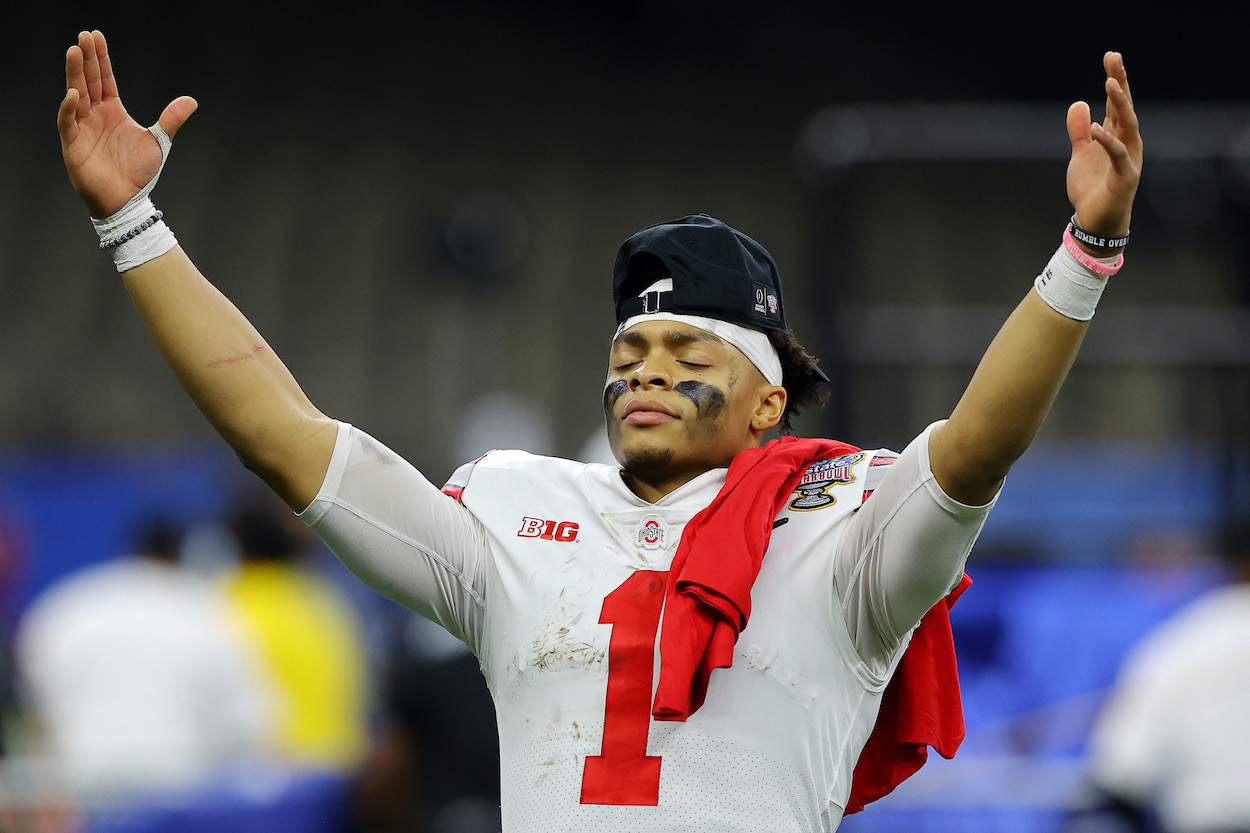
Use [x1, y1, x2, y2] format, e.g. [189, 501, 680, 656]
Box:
[299, 423, 489, 655]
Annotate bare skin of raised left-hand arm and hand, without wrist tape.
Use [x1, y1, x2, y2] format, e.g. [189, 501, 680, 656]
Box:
[58, 31, 336, 510]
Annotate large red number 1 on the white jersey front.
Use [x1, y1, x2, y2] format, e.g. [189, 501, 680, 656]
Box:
[581, 570, 669, 807]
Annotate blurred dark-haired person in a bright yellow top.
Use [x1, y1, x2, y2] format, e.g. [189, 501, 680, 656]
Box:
[225, 493, 369, 772]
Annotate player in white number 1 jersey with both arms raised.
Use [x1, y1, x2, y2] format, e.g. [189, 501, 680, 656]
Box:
[58, 31, 1143, 833]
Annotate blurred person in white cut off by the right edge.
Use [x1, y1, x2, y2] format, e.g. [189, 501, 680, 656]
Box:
[1068, 514, 1250, 833]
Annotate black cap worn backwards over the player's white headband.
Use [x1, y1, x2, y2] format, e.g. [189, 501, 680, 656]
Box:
[613, 214, 786, 330]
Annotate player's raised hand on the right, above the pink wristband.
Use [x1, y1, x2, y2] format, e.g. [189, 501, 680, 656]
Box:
[1068, 53, 1141, 246]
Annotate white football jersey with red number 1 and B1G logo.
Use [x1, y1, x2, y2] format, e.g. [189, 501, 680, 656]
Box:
[303, 417, 988, 833]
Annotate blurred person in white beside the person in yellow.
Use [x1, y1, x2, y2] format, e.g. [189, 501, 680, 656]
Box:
[16, 522, 271, 807]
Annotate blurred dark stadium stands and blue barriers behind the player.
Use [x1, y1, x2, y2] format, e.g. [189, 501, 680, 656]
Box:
[0, 0, 1250, 833]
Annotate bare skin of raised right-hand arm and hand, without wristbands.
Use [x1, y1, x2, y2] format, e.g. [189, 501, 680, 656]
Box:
[929, 53, 1141, 505]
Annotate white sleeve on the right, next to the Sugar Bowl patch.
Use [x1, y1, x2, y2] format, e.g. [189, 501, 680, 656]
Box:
[834, 423, 998, 675]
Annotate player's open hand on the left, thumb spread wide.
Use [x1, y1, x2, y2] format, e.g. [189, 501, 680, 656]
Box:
[56, 31, 198, 218]
